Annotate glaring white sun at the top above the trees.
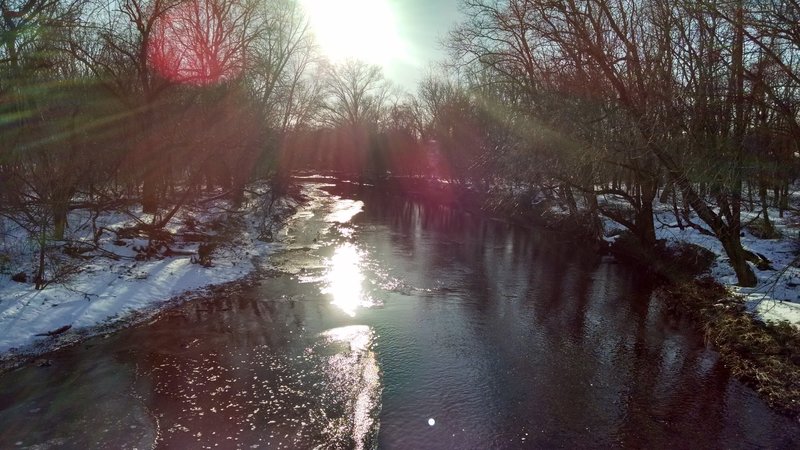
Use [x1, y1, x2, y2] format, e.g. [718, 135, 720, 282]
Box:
[301, 0, 406, 66]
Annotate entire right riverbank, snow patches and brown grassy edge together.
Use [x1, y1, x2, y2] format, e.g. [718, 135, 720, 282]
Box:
[366, 180, 800, 420]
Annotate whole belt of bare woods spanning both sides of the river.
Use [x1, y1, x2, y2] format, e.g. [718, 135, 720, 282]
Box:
[0, 0, 800, 286]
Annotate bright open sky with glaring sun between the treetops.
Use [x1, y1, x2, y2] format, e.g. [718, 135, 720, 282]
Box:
[301, 0, 460, 92]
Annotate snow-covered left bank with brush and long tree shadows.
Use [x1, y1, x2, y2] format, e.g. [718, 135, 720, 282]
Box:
[0, 185, 306, 356]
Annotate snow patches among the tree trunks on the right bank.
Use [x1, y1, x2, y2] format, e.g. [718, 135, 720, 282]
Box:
[655, 204, 800, 327]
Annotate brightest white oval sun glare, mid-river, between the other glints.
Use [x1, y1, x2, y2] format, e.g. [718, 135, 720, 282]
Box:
[322, 242, 371, 317]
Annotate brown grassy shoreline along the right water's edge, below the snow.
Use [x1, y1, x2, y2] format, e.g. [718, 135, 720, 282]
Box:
[340, 180, 800, 423]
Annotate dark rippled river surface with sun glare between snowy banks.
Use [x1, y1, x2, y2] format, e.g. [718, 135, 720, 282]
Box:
[0, 182, 800, 449]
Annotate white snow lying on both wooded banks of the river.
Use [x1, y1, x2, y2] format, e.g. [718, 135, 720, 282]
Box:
[0, 176, 800, 356]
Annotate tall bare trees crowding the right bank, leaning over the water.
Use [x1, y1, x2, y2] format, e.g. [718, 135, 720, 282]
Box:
[444, 0, 800, 286]
